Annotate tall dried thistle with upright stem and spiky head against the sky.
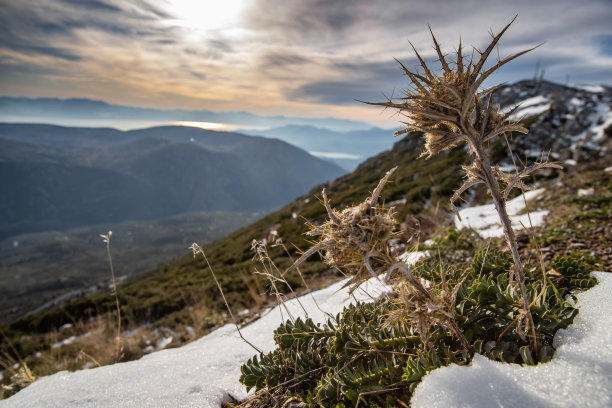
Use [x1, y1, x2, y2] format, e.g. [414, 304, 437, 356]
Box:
[368, 16, 560, 353]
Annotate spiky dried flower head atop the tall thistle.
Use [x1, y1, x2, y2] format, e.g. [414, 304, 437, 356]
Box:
[371, 17, 533, 156]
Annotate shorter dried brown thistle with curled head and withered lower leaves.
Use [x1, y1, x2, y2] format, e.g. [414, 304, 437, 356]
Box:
[288, 167, 471, 350]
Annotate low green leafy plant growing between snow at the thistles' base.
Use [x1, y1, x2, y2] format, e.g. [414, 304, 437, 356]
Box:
[240, 249, 587, 407]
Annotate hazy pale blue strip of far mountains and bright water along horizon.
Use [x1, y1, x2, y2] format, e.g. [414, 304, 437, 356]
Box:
[0, 97, 371, 132]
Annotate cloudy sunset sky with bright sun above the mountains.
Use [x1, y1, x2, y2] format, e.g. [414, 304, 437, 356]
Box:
[0, 0, 612, 126]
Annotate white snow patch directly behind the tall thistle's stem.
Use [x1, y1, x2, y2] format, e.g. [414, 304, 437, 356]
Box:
[455, 189, 548, 238]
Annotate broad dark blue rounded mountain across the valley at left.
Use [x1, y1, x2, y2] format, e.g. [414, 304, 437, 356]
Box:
[0, 124, 344, 239]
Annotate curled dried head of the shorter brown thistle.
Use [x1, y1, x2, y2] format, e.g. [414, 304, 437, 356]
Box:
[288, 167, 397, 293]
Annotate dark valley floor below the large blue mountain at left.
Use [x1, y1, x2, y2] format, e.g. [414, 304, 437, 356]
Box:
[0, 211, 263, 323]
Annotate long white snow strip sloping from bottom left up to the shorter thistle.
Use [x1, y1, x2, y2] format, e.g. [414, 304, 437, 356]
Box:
[0, 282, 382, 408]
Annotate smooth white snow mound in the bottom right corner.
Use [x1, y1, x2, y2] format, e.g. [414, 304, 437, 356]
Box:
[411, 272, 612, 408]
